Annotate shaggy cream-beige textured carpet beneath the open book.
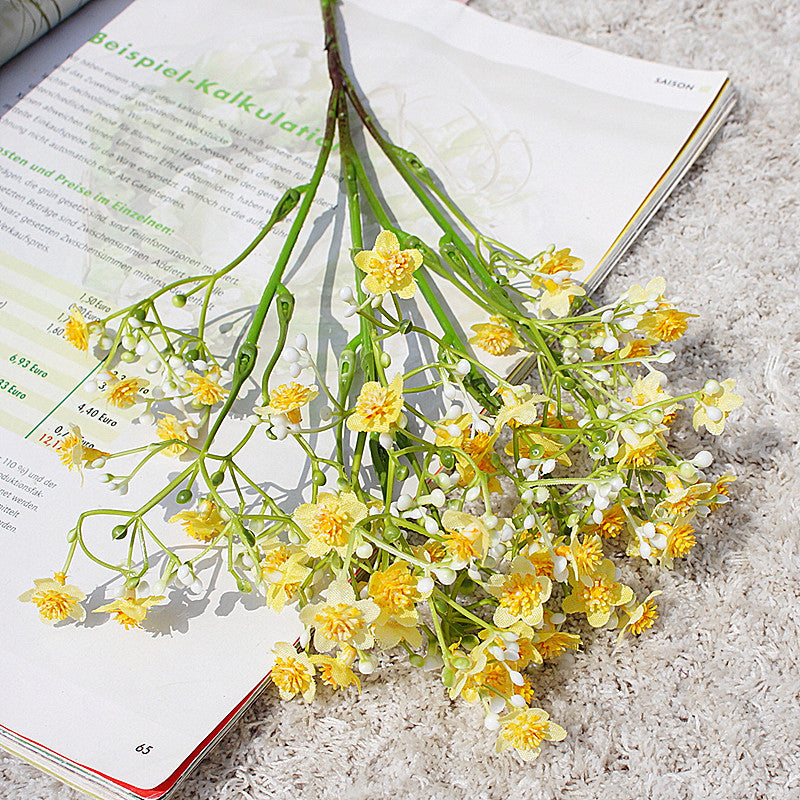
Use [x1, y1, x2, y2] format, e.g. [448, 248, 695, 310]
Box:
[0, 0, 800, 800]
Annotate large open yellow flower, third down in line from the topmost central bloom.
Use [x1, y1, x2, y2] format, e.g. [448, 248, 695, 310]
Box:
[292, 492, 367, 558]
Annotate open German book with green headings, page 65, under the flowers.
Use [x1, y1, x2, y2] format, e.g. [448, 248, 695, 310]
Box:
[0, 0, 733, 798]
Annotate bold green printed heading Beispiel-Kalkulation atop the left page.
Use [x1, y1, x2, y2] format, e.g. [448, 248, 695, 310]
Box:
[89, 32, 336, 149]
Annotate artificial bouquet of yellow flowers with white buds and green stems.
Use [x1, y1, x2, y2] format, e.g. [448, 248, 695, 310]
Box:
[20, 0, 741, 760]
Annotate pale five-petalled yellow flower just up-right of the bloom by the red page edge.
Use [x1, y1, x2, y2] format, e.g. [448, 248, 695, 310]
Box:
[300, 580, 380, 653]
